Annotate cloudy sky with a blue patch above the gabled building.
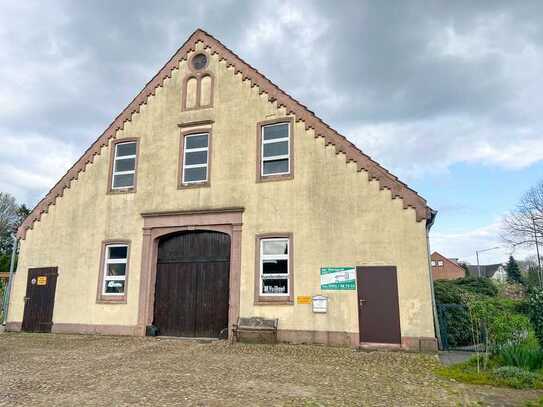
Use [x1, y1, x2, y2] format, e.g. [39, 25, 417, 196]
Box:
[0, 0, 543, 263]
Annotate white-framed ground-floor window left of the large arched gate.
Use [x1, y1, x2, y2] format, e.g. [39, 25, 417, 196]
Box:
[102, 244, 128, 296]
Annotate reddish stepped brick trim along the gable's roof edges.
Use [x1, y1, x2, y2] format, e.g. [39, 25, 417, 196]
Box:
[17, 29, 431, 239]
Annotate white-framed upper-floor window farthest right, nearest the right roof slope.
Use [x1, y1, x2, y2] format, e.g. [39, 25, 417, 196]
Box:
[260, 123, 290, 177]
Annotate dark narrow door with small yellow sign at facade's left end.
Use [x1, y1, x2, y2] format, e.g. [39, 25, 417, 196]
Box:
[22, 267, 58, 332]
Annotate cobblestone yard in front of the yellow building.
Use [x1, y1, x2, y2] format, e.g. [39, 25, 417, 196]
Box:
[0, 333, 542, 407]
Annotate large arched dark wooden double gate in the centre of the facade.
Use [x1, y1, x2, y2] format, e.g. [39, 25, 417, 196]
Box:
[154, 231, 230, 338]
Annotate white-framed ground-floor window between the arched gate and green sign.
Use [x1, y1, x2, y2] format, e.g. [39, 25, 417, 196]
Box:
[260, 238, 291, 296]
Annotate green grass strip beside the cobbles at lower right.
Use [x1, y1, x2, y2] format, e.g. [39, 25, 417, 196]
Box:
[436, 357, 543, 389]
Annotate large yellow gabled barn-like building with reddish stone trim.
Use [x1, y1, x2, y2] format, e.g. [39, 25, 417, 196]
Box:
[8, 30, 436, 349]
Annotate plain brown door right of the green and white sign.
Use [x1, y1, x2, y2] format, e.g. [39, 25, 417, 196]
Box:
[356, 266, 401, 344]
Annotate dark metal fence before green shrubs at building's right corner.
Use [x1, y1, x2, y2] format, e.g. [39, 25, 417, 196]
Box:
[437, 304, 486, 352]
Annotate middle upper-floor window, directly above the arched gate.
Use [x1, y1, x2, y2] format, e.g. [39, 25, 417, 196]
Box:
[181, 133, 209, 185]
